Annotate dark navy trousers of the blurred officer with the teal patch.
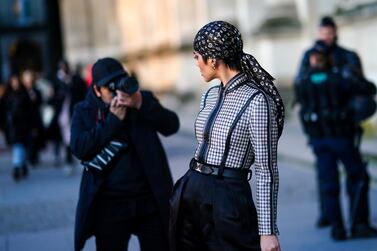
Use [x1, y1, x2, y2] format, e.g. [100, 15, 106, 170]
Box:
[311, 138, 369, 230]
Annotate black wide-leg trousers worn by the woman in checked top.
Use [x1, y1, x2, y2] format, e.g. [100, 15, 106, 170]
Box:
[170, 170, 261, 251]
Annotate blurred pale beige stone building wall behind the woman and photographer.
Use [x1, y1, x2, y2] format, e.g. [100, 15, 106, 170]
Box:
[60, 0, 377, 93]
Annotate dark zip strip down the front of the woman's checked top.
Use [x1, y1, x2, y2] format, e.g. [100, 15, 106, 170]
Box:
[198, 86, 225, 163]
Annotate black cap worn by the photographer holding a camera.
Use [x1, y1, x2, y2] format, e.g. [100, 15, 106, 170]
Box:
[92, 58, 128, 86]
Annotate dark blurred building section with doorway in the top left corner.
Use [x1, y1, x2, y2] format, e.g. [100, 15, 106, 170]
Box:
[0, 0, 63, 83]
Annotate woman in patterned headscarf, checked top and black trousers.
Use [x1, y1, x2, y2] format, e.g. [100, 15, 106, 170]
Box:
[170, 21, 284, 251]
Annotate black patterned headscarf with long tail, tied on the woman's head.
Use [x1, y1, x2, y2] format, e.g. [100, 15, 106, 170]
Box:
[194, 21, 284, 136]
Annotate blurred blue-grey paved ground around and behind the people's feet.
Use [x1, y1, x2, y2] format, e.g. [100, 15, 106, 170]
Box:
[0, 108, 377, 251]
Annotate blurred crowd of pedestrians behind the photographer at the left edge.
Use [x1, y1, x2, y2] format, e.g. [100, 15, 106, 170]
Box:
[0, 60, 88, 181]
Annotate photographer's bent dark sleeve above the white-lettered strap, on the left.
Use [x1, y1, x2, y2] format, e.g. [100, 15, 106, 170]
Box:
[71, 105, 123, 160]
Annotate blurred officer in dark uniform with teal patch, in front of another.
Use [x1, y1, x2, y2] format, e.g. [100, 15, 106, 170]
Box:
[295, 38, 377, 240]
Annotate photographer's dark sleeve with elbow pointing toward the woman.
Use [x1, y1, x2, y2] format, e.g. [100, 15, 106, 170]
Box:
[139, 91, 179, 136]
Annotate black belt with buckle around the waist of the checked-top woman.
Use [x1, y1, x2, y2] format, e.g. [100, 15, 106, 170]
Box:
[190, 158, 251, 180]
